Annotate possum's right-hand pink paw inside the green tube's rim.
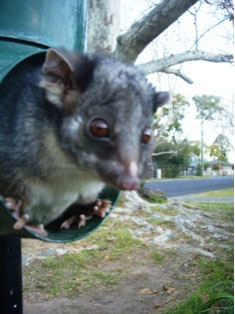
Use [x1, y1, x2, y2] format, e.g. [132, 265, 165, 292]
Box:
[61, 200, 111, 229]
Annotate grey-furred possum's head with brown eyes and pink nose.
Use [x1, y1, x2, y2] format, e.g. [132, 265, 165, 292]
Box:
[41, 49, 169, 190]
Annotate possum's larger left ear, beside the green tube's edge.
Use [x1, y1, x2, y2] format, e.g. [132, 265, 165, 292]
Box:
[40, 48, 94, 111]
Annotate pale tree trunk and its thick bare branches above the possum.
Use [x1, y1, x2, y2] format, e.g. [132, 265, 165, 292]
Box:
[87, 0, 233, 76]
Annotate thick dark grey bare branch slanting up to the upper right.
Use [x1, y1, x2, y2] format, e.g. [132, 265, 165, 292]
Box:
[115, 0, 198, 62]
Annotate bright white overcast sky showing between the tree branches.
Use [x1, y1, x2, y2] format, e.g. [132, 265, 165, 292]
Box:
[121, 0, 234, 159]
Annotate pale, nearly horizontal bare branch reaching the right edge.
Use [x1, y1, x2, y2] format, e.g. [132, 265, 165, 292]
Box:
[138, 50, 233, 74]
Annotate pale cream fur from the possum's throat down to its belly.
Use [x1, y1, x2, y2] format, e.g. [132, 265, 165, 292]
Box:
[24, 130, 104, 224]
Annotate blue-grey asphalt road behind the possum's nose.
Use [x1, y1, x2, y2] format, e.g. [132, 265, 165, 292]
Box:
[145, 176, 234, 197]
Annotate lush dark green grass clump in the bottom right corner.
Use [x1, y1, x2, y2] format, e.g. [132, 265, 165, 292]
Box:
[167, 252, 234, 314]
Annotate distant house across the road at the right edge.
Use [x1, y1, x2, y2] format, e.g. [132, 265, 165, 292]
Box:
[203, 160, 234, 176]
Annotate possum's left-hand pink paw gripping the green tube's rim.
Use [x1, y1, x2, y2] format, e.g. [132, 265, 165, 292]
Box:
[5, 197, 48, 236]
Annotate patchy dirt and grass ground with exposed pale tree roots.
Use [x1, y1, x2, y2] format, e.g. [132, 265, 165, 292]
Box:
[23, 193, 233, 314]
